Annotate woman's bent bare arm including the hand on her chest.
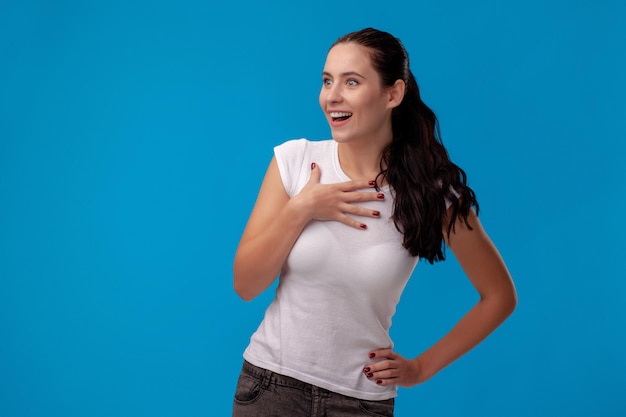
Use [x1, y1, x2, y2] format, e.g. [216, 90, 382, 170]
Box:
[233, 158, 384, 301]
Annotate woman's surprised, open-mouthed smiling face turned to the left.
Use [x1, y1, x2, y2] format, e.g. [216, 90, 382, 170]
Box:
[320, 43, 394, 143]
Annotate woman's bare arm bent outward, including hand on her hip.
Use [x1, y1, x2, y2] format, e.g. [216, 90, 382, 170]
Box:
[364, 210, 517, 387]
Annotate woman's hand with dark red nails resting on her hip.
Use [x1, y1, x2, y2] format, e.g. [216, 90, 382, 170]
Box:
[363, 349, 427, 388]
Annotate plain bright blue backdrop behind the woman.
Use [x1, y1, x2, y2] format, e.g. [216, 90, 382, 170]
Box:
[0, 0, 626, 417]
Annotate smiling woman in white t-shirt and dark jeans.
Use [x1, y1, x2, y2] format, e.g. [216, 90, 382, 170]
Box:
[233, 28, 516, 416]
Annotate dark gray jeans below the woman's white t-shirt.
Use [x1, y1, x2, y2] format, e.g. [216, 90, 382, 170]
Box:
[233, 361, 394, 417]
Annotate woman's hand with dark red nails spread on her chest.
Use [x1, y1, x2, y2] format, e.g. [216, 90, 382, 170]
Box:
[291, 162, 385, 229]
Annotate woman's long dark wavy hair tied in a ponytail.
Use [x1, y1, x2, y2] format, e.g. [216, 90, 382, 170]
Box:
[333, 28, 478, 264]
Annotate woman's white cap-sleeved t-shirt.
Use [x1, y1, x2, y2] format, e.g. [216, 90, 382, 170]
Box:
[244, 139, 418, 400]
